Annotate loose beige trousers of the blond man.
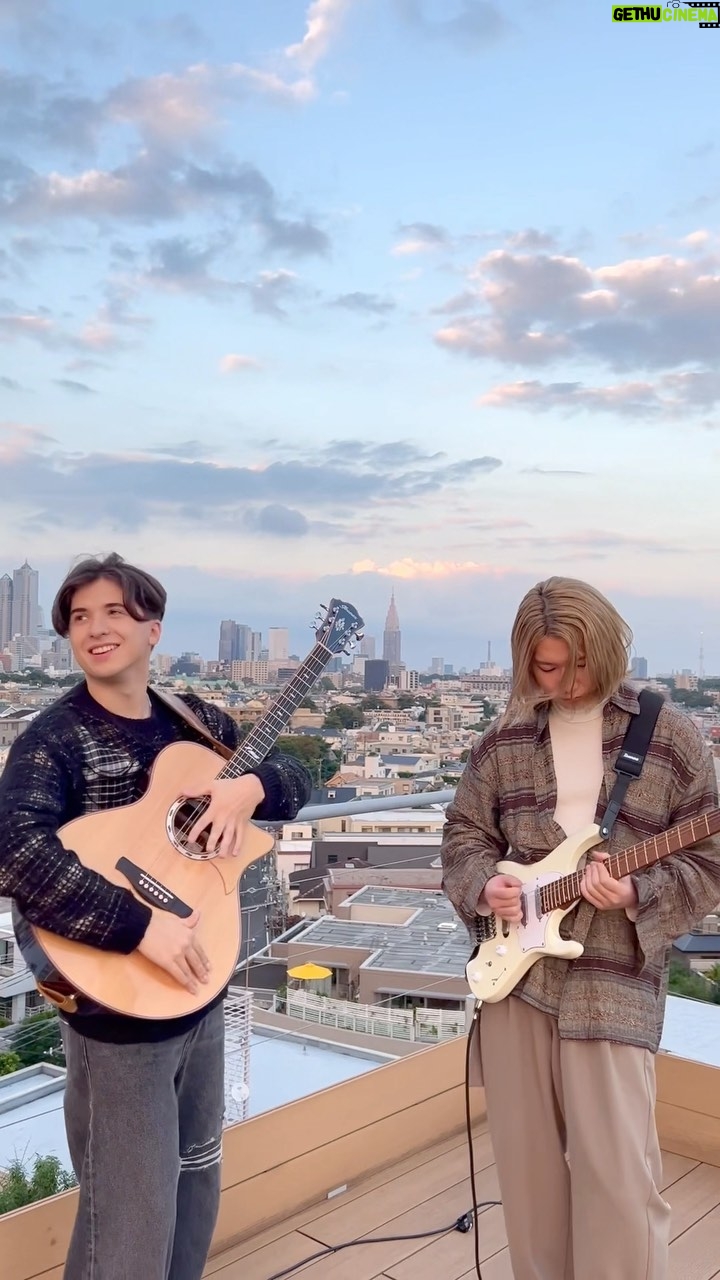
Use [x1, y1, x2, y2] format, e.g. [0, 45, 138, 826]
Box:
[480, 996, 670, 1280]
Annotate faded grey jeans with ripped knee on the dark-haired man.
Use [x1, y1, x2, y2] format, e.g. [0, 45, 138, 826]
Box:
[63, 1004, 224, 1280]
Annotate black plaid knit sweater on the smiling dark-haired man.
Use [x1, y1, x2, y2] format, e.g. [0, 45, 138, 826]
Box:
[0, 682, 311, 1034]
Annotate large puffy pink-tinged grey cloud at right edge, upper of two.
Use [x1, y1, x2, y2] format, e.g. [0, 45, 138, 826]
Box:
[434, 240, 720, 370]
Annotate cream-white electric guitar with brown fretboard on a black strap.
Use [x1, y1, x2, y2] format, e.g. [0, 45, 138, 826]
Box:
[465, 809, 720, 1005]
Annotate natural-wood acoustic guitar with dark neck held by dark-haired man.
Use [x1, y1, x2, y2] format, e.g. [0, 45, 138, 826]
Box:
[15, 599, 363, 1019]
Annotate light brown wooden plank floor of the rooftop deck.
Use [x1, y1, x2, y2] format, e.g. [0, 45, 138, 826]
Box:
[205, 1126, 720, 1280]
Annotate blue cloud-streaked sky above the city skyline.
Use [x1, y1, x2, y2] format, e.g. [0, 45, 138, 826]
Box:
[0, 0, 720, 671]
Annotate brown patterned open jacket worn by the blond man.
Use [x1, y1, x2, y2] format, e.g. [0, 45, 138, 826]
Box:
[442, 684, 720, 1052]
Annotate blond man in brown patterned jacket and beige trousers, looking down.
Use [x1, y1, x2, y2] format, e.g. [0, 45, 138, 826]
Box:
[442, 577, 720, 1280]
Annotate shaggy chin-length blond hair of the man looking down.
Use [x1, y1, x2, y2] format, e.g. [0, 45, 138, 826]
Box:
[507, 577, 633, 718]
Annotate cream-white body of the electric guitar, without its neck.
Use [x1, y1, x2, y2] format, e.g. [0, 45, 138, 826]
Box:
[465, 826, 600, 1004]
